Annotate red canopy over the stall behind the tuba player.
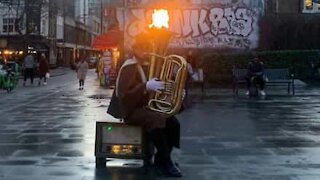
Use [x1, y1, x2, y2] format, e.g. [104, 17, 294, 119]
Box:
[92, 30, 123, 49]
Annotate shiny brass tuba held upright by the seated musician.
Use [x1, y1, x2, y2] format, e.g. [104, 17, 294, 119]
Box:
[148, 28, 187, 116]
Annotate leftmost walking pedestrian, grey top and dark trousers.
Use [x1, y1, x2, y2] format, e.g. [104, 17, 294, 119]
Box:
[23, 53, 36, 86]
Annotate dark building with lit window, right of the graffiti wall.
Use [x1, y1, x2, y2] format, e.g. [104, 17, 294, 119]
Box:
[259, 0, 320, 50]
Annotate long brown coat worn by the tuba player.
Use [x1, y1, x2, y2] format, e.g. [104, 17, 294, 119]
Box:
[108, 59, 166, 131]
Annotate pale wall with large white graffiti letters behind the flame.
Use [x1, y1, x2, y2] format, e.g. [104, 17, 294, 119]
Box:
[117, 0, 263, 49]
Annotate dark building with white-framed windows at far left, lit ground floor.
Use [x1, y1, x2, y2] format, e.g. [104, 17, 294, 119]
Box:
[0, 0, 49, 64]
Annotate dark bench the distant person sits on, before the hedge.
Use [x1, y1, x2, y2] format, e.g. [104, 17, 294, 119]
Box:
[232, 68, 295, 95]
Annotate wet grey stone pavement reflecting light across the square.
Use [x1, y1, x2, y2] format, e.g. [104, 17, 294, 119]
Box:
[0, 70, 320, 180]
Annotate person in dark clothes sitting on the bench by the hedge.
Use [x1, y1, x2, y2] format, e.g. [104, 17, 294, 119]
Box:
[246, 57, 266, 96]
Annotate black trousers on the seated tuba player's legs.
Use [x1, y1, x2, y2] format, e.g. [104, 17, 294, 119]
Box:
[150, 116, 180, 165]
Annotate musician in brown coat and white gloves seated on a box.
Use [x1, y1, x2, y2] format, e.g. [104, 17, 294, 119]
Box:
[108, 43, 182, 177]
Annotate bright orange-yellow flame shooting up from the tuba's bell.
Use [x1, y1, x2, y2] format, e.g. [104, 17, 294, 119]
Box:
[149, 9, 169, 28]
